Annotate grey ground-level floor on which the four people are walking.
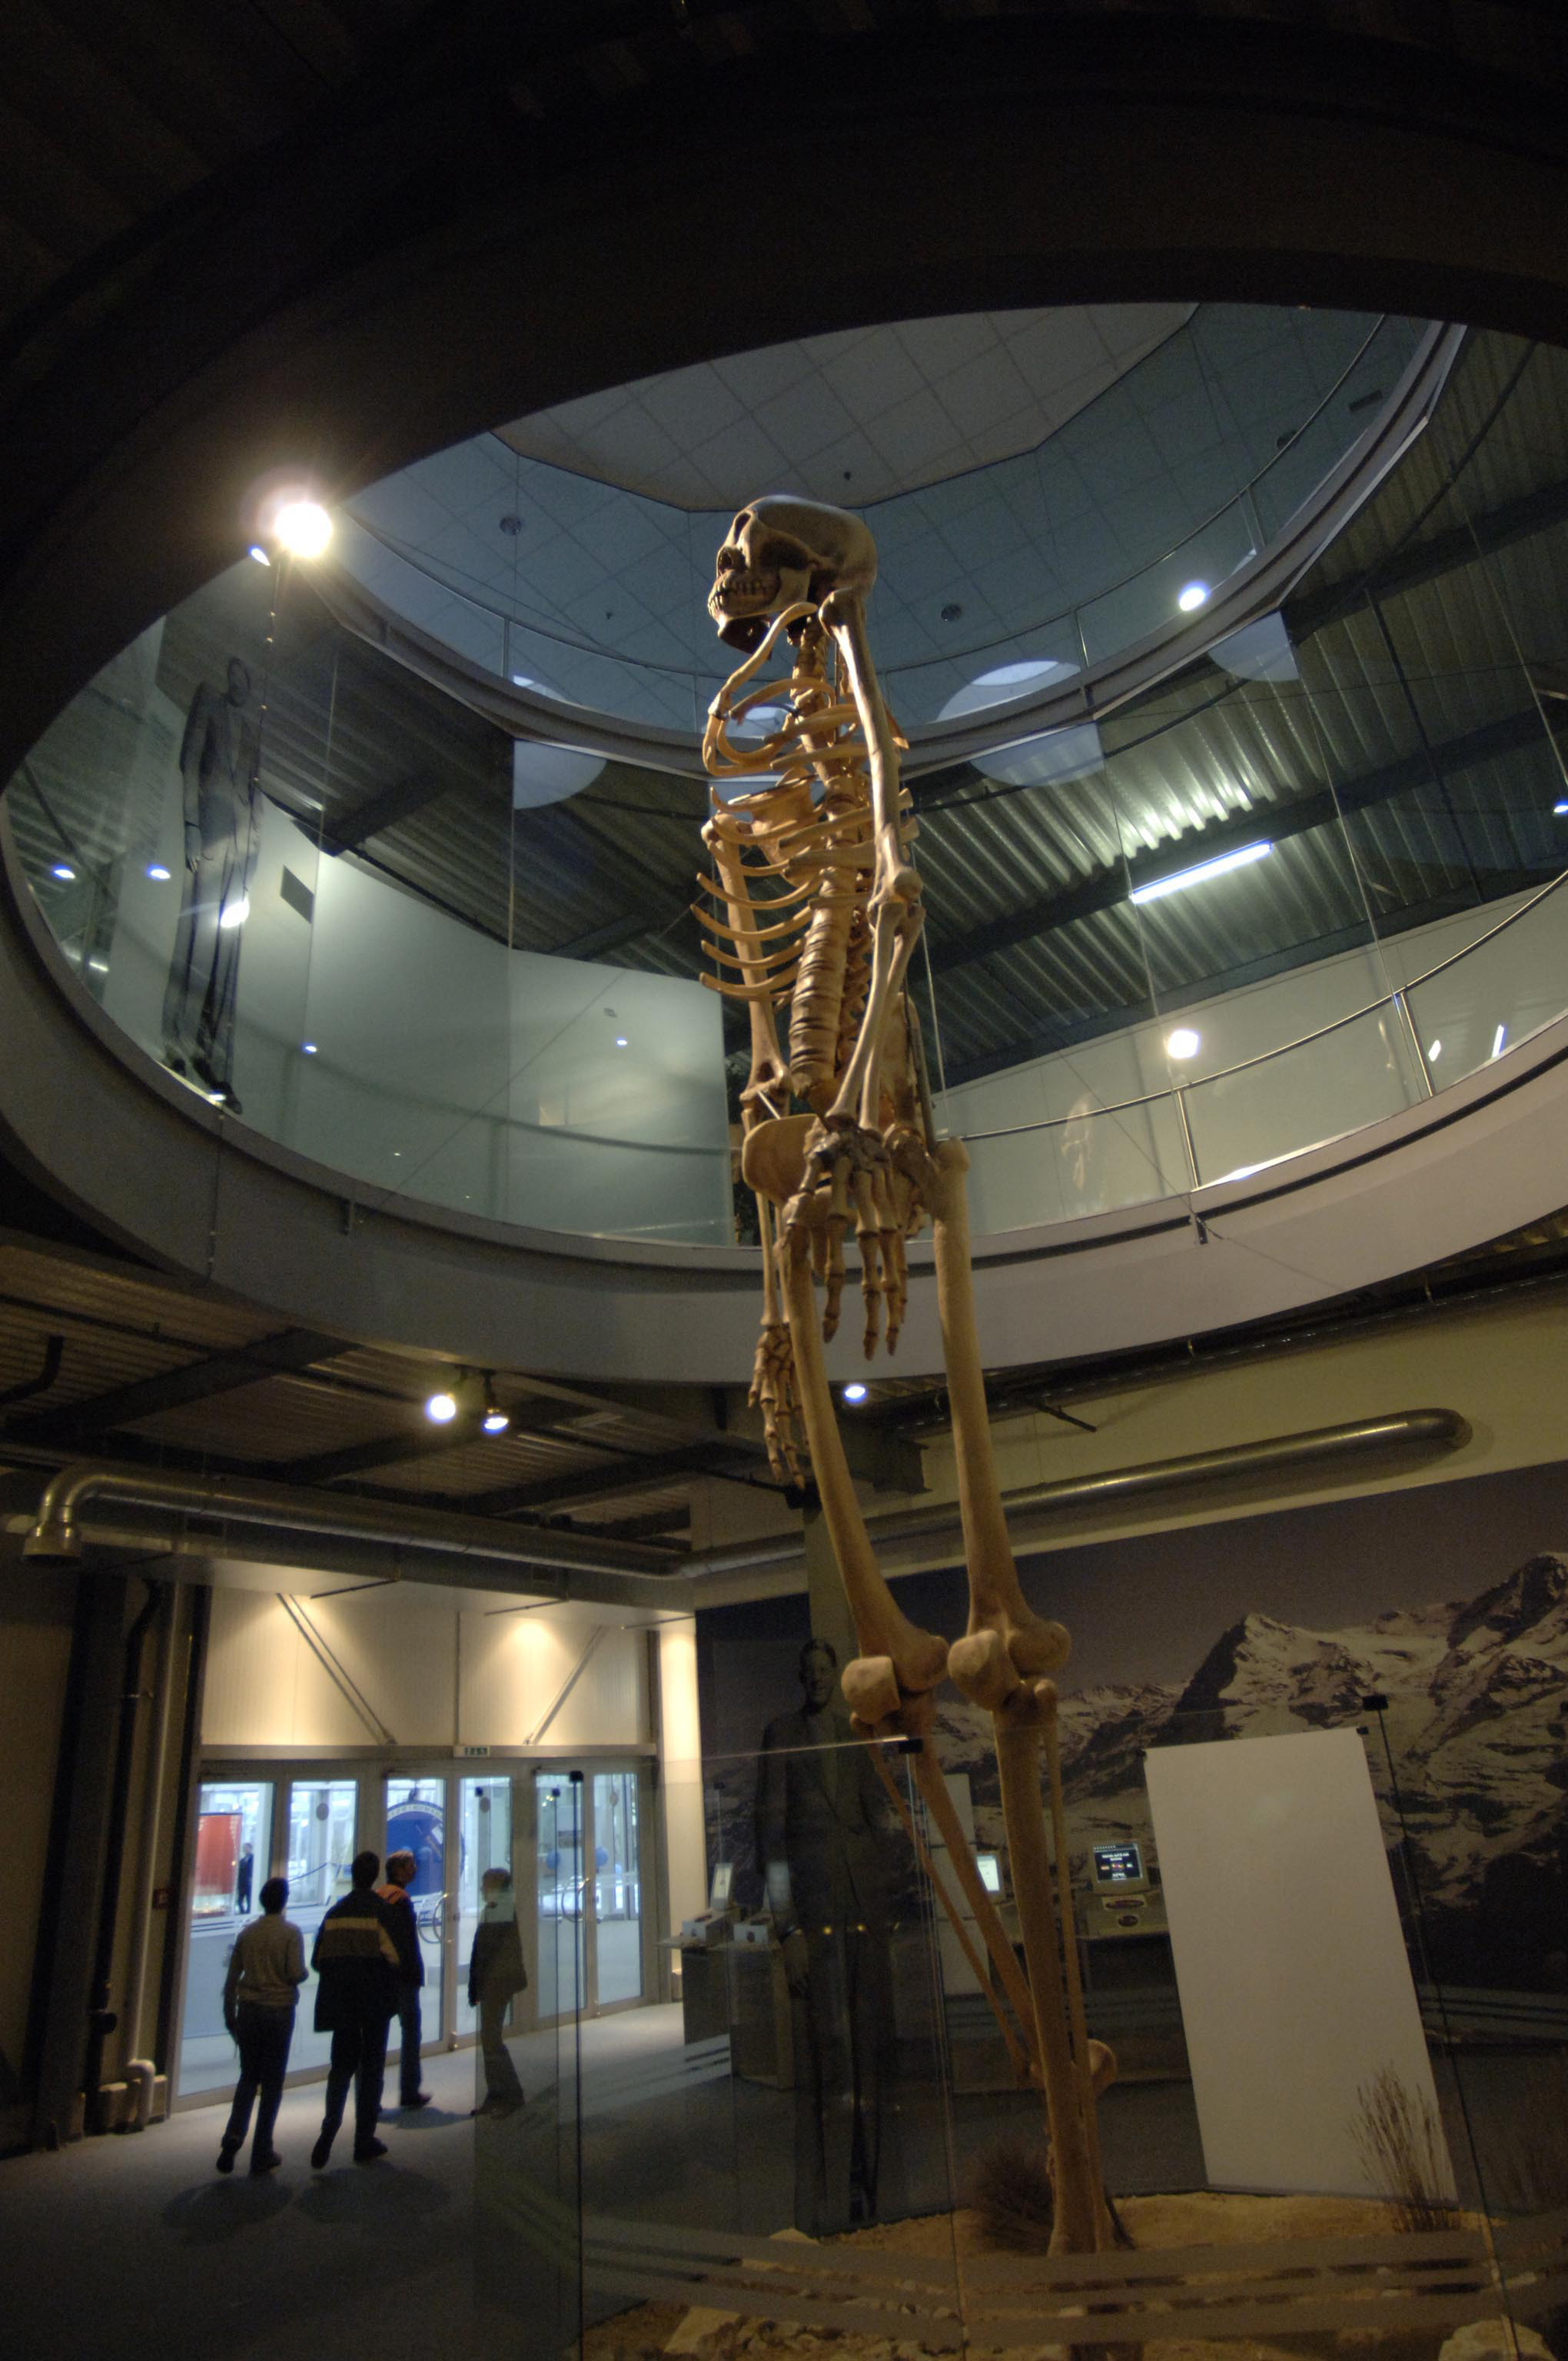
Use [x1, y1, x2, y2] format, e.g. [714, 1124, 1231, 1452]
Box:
[0, 2007, 1528, 2361]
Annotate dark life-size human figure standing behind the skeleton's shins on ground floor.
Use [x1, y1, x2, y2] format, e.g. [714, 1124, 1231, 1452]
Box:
[756, 1638, 892, 2238]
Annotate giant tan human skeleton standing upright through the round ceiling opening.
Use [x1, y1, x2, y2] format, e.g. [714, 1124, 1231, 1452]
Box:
[696, 496, 1115, 2253]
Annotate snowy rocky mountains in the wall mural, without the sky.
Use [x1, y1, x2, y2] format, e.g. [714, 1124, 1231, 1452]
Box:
[711, 1554, 1568, 1990]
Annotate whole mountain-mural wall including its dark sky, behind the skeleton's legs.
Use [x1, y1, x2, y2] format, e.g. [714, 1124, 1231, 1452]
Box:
[699, 1461, 1568, 1990]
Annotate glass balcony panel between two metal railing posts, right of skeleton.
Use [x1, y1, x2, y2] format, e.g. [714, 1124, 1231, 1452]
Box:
[1181, 1001, 1424, 1188]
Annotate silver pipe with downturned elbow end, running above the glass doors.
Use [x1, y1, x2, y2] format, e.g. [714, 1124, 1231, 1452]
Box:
[22, 1459, 683, 1587]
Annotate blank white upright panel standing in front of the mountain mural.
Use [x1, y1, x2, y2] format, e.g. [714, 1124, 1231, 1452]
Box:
[1145, 1731, 1452, 2196]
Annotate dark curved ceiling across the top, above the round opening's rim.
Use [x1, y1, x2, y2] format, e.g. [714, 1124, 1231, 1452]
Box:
[0, 0, 1568, 797]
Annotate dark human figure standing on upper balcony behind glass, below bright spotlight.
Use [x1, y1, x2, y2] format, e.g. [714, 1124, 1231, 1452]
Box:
[163, 657, 257, 1115]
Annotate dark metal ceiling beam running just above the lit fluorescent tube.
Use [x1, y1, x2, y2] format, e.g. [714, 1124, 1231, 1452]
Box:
[930, 706, 1544, 975]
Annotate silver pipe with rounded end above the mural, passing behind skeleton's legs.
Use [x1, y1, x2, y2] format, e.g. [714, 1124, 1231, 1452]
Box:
[687, 1409, 1469, 1575]
